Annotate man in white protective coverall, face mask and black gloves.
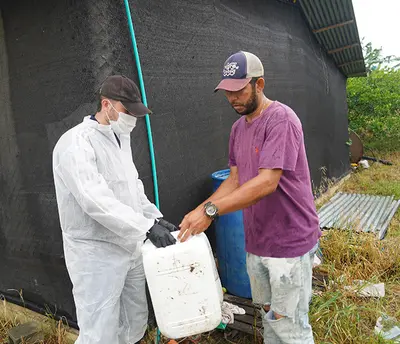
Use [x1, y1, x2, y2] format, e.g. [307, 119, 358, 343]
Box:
[53, 75, 176, 344]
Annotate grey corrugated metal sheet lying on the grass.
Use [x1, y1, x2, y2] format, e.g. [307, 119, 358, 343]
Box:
[318, 192, 400, 239]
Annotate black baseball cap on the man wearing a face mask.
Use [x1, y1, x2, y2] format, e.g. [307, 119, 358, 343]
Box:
[100, 75, 151, 117]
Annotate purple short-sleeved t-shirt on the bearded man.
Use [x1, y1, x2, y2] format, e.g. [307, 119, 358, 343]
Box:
[229, 101, 321, 258]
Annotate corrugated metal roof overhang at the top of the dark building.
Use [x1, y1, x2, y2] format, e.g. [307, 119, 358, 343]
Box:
[300, 0, 366, 77]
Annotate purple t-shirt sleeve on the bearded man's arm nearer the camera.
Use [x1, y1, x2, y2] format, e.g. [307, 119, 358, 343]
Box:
[259, 120, 302, 171]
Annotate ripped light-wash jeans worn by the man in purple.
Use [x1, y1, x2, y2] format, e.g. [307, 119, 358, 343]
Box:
[247, 246, 317, 344]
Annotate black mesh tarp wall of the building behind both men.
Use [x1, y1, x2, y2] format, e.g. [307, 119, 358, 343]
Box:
[0, 0, 348, 319]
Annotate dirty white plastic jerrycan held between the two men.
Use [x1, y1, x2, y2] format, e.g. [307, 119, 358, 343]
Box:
[142, 232, 222, 339]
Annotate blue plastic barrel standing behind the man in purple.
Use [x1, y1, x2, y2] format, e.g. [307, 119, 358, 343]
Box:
[212, 170, 251, 299]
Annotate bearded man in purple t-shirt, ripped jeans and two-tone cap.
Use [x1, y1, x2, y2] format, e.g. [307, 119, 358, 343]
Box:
[179, 51, 321, 344]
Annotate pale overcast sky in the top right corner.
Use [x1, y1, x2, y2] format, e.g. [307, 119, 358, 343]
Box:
[353, 0, 400, 56]
